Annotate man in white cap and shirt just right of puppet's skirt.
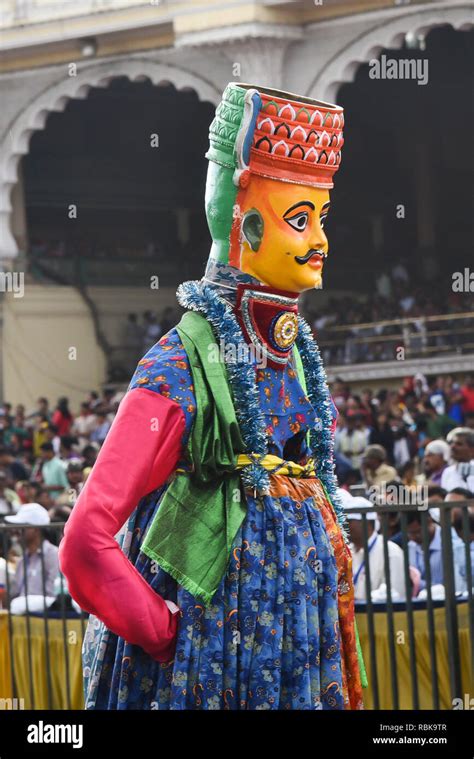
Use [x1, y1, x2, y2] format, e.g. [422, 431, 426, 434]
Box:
[339, 491, 405, 601]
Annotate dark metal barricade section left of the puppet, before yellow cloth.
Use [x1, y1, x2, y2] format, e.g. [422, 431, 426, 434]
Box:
[0, 522, 87, 709]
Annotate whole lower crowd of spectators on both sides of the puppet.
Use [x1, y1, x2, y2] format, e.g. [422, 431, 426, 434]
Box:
[0, 375, 474, 613]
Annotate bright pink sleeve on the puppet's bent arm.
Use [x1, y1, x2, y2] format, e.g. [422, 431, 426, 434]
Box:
[59, 388, 185, 661]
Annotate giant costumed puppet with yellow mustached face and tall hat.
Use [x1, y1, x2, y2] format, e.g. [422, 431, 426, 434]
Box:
[60, 83, 365, 710]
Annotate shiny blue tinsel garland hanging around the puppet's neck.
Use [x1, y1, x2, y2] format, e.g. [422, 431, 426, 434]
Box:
[177, 281, 346, 534]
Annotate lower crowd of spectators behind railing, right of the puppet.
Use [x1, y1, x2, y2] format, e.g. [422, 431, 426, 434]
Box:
[332, 375, 474, 601]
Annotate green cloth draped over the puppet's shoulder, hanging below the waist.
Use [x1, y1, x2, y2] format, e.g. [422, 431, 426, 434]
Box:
[141, 311, 247, 605]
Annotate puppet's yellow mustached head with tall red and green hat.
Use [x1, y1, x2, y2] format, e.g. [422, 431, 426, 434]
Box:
[206, 84, 343, 293]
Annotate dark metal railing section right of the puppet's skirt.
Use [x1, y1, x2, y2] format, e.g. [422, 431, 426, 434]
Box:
[347, 486, 474, 710]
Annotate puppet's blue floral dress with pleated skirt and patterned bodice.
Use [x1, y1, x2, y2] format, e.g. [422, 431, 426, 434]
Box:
[83, 330, 356, 710]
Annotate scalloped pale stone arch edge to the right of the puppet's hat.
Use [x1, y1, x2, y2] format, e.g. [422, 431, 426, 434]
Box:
[307, 2, 474, 102]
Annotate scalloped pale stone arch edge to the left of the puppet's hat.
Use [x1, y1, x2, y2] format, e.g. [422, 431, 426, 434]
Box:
[0, 58, 221, 259]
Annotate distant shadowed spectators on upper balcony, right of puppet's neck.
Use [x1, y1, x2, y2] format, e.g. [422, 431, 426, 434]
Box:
[309, 262, 474, 366]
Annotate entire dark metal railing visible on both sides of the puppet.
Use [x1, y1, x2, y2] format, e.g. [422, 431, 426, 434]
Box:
[0, 500, 474, 710]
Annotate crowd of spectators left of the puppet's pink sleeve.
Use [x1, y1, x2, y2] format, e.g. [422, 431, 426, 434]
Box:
[0, 388, 123, 613]
